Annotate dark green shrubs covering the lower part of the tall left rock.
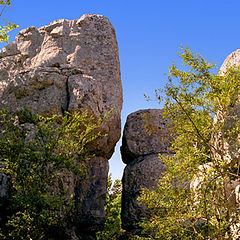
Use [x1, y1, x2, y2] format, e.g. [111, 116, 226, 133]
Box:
[0, 109, 104, 240]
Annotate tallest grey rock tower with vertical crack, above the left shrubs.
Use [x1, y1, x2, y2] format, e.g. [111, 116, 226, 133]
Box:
[0, 15, 122, 239]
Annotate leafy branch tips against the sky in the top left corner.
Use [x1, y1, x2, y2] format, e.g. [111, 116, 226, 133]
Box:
[0, 0, 18, 43]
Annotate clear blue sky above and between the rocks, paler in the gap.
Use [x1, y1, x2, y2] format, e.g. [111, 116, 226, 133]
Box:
[4, 0, 240, 179]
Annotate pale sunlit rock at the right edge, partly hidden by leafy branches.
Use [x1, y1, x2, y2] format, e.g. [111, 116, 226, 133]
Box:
[205, 49, 240, 239]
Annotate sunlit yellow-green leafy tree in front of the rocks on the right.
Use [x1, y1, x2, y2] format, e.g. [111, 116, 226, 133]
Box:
[136, 48, 240, 240]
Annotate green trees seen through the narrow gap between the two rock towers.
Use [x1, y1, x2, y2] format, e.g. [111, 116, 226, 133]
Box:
[97, 175, 123, 240]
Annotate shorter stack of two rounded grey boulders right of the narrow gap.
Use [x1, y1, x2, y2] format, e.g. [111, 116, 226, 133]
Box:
[121, 109, 173, 233]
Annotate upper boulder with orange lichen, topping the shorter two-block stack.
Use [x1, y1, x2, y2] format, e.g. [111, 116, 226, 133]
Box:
[121, 109, 171, 164]
